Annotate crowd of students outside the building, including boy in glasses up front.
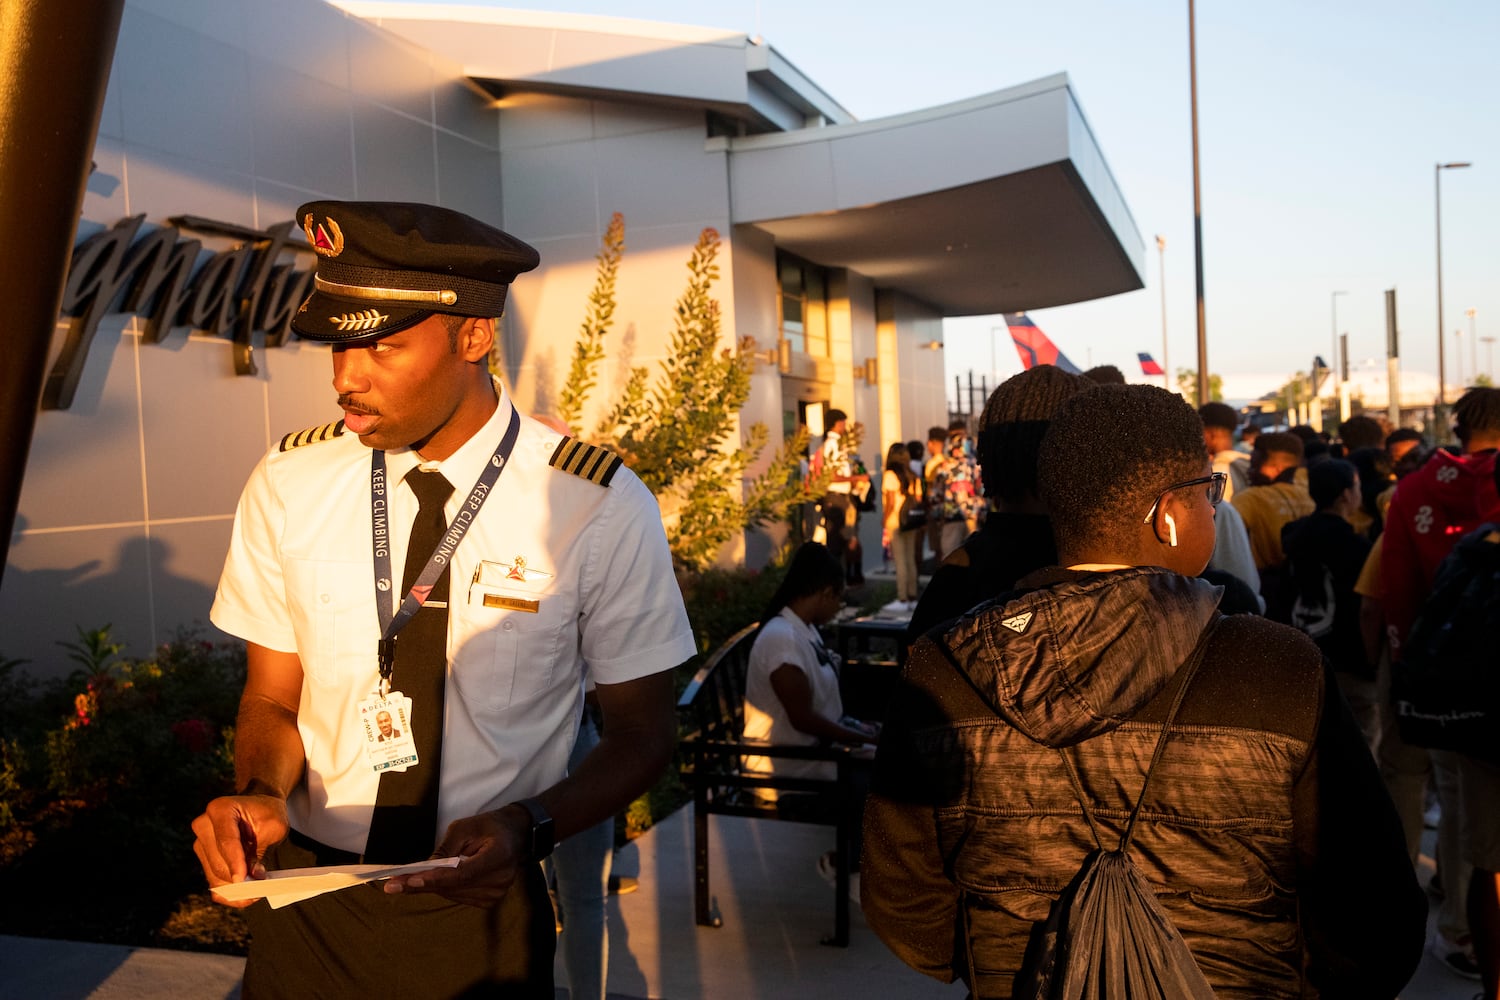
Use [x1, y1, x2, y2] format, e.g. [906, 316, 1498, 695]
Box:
[773, 374, 1500, 1000]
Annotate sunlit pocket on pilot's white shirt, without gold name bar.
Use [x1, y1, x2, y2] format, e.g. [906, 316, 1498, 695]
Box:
[287, 559, 373, 687]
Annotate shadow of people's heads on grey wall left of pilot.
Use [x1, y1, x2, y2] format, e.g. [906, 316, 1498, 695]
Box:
[0, 516, 227, 679]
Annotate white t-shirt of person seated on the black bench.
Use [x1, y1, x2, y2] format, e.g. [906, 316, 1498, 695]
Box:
[741, 607, 843, 799]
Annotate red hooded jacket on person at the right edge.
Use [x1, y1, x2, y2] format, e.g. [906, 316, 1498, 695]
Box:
[1380, 450, 1500, 652]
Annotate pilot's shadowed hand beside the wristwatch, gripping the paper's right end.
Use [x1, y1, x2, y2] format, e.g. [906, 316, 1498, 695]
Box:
[386, 805, 531, 907]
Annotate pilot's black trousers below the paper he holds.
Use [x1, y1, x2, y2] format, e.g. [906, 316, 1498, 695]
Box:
[242, 835, 555, 1000]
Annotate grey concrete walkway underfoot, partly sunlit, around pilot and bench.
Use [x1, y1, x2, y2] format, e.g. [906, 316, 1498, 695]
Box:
[0, 810, 1479, 1000]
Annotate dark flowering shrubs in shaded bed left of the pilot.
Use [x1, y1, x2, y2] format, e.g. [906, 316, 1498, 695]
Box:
[0, 625, 245, 951]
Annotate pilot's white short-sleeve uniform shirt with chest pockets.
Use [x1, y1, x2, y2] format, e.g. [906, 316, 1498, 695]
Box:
[210, 391, 696, 853]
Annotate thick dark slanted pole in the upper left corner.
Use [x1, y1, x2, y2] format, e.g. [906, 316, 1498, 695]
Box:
[0, 0, 125, 587]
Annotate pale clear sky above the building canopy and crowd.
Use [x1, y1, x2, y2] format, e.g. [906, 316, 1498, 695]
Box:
[402, 0, 1500, 399]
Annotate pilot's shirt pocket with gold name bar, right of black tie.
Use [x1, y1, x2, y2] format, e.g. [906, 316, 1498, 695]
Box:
[449, 586, 575, 712]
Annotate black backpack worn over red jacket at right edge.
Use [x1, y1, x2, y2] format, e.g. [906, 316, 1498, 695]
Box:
[1391, 523, 1500, 762]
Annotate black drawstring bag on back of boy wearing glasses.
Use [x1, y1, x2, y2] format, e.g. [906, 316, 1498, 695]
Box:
[1013, 618, 1218, 1000]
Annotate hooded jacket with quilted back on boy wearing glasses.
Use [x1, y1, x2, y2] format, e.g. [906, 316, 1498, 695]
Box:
[861, 567, 1427, 1000]
